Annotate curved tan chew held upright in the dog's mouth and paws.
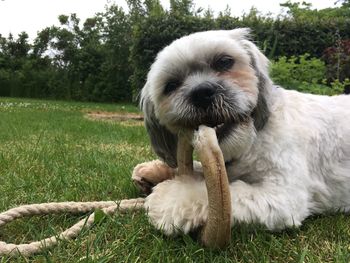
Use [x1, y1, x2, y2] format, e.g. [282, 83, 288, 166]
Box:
[178, 126, 231, 248]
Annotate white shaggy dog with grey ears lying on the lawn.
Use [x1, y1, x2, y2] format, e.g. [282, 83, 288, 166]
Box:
[132, 28, 350, 235]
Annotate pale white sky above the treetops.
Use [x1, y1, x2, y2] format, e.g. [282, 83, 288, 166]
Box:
[0, 0, 335, 39]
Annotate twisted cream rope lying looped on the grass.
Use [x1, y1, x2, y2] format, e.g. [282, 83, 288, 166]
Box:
[0, 198, 144, 257]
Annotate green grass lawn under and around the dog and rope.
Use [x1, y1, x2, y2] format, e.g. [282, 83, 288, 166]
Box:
[0, 98, 350, 263]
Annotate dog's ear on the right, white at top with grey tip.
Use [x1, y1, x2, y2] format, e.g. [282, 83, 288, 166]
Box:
[242, 40, 272, 131]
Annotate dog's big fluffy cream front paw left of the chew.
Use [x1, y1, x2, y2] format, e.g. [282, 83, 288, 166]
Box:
[145, 176, 208, 235]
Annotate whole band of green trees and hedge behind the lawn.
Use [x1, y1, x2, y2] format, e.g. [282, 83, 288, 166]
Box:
[0, 0, 350, 102]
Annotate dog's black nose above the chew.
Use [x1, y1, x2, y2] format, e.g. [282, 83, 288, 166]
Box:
[190, 82, 217, 108]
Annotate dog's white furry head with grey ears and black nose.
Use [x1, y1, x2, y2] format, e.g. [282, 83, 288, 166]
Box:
[141, 29, 271, 167]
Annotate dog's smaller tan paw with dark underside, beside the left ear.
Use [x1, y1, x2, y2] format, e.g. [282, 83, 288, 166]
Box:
[131, 160, 176, 194]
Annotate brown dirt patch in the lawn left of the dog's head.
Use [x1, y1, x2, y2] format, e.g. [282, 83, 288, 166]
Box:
[86, 111, 143, 122]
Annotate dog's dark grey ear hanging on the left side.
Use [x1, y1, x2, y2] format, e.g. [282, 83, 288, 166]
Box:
[140, 87, 177, 168]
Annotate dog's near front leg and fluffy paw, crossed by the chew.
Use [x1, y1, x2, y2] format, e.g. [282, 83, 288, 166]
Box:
[145, 176, 309, 235]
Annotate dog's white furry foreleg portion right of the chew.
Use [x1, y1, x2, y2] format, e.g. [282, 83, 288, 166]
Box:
[230, 181, 311, 231]
